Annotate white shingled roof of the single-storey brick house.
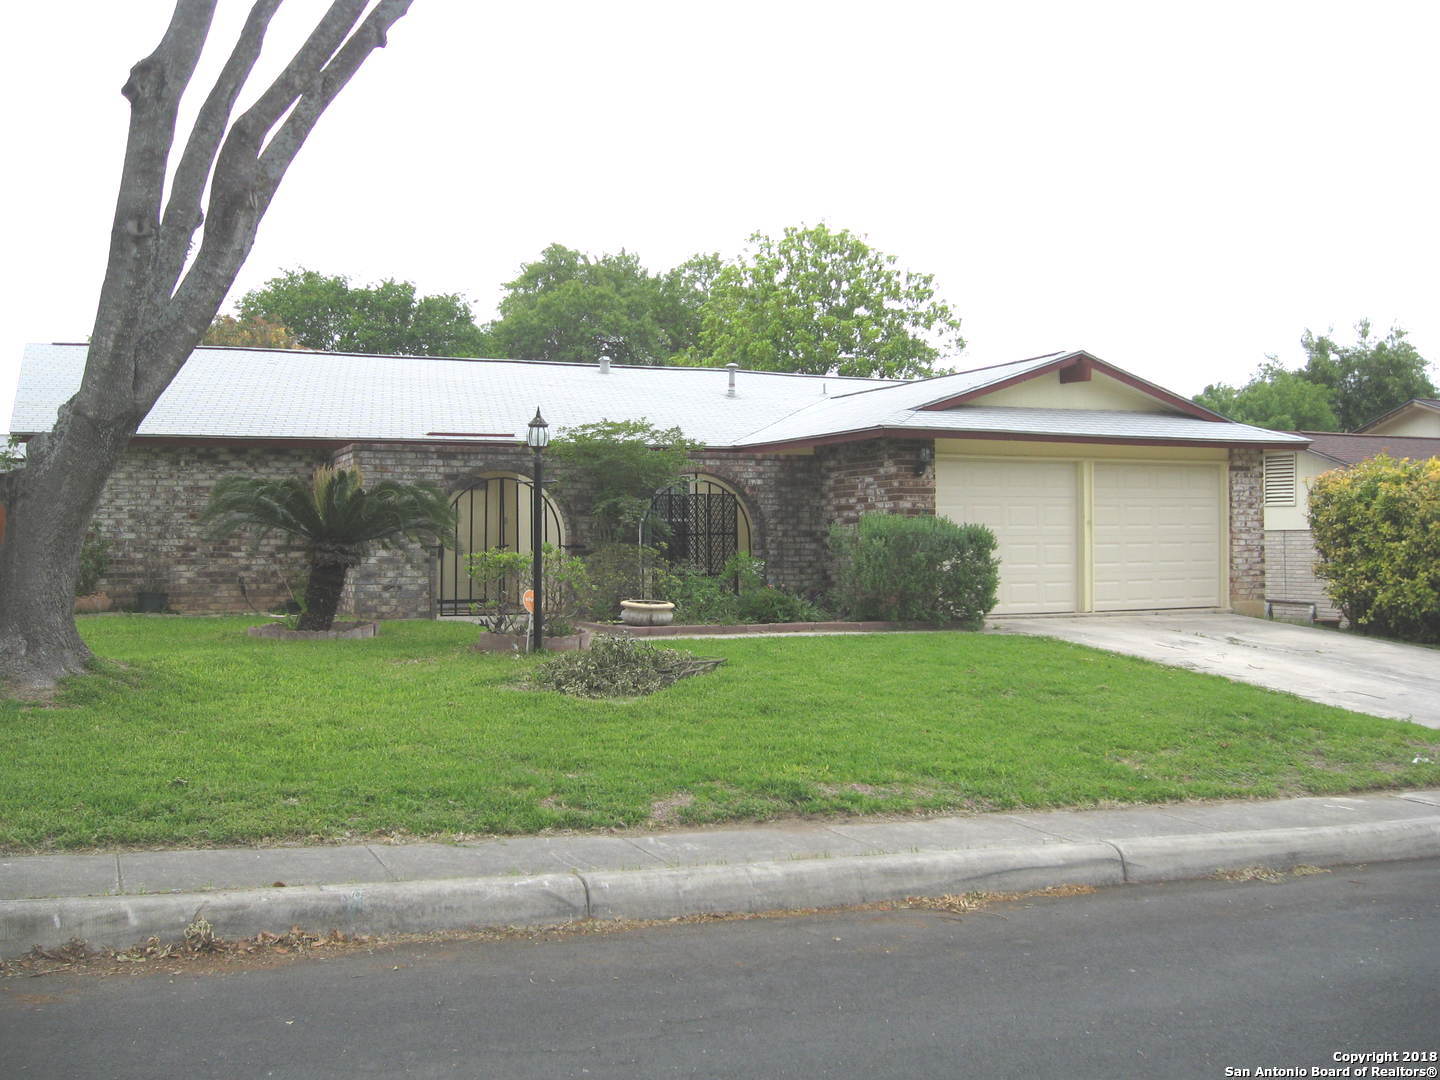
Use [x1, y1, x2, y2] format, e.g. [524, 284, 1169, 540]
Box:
[10, 344, 1305, 448]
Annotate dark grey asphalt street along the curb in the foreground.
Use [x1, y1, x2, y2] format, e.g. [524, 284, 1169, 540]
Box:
[0, 860, 1440, 1080]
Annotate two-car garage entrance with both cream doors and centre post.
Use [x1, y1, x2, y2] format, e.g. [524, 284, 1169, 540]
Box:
[936, 456, 1224, 615]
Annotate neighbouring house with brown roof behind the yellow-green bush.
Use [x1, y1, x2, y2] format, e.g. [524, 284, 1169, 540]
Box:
[1264, 429, 1440, 621]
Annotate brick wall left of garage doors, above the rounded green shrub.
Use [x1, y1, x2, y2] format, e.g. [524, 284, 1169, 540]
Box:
[815, 439, 935, 524]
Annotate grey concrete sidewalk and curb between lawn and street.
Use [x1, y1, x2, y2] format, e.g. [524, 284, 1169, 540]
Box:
[0, 791, 1440, 956]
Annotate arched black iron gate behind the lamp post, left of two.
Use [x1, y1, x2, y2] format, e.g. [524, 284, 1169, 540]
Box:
[435, 477, 564, 615]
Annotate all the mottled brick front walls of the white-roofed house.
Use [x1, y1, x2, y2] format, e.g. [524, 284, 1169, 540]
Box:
[87, 439, 1274, 619]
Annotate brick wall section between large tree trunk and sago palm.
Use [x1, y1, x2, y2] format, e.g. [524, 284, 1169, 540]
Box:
[94, 442, 330, 613]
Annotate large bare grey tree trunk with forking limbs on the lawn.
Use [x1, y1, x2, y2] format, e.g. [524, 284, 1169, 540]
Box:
[0, 0, 410, 693]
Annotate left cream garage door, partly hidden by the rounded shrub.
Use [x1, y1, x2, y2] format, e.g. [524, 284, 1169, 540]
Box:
[935, 458, 1079, 615]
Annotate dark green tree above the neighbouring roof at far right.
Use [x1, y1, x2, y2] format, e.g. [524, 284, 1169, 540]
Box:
[1300, 320, 1436, 431]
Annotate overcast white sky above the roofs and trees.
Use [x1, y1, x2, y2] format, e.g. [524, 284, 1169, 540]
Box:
[0, 0, 1440, 431]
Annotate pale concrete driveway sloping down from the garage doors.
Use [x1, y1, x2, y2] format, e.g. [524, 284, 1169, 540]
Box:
[988, 612, 1440, 727]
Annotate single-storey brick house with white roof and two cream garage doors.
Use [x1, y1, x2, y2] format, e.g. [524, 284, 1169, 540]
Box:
[12, 344, 1309, 618]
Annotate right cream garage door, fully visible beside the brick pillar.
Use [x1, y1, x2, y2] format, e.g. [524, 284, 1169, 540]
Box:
[1093, 462, 1221, 611]
